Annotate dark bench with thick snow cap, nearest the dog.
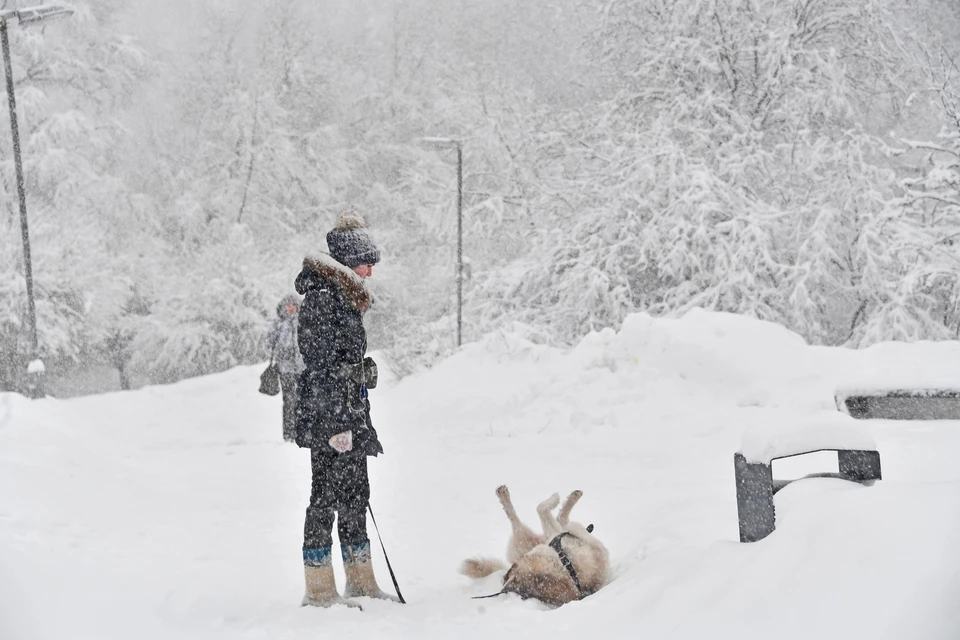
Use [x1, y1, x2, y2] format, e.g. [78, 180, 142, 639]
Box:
[733, 416, 880, 542]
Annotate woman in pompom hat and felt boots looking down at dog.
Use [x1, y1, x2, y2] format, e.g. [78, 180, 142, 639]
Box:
[296, 210, 394, 607]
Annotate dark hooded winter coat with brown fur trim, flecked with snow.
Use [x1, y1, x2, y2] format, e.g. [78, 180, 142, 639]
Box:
[295, 254, 383, 457]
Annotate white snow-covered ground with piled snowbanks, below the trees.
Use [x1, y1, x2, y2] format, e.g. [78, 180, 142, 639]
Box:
[0, 312, 960, 640]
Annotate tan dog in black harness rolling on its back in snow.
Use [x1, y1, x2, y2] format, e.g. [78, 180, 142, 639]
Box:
[460, 486, 610, 607]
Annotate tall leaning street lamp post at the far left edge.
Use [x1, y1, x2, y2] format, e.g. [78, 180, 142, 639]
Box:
[0, 4, 73, 398]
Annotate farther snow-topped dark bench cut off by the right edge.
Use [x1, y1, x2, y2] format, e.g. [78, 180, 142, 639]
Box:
[834, 387, 960, 420]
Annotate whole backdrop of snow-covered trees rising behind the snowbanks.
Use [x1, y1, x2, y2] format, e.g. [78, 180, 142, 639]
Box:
[0, 0, 960, 388]
